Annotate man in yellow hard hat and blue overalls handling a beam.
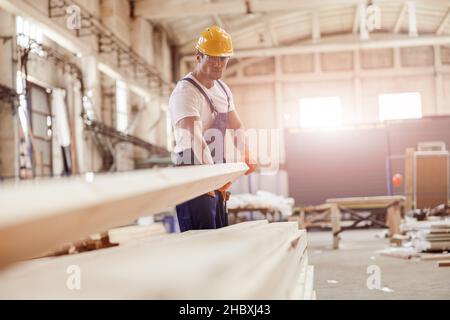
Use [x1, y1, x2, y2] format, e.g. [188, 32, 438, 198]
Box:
[169, 26, 256, 232]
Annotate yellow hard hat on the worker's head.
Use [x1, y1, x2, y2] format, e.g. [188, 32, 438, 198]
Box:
[196, 26, 233, 57]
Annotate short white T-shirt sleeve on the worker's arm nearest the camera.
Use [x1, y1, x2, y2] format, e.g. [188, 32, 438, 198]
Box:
[169, 87, 200, 126]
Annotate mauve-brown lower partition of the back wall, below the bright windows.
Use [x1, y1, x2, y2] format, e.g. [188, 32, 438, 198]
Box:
[286, 116, 450, 205]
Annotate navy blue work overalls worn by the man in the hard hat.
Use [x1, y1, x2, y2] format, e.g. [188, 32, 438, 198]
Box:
[176, 78, 230, 232]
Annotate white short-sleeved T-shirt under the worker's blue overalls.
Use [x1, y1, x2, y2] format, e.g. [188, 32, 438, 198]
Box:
[168, 73, 235, 153]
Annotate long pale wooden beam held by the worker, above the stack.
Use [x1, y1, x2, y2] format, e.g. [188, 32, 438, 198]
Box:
[0, 163, 247, 268]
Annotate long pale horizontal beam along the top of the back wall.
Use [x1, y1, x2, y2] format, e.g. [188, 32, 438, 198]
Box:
[183, 35, 450, 61]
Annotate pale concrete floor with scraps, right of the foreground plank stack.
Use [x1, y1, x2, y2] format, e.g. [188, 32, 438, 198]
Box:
[308, 230, 450, 300]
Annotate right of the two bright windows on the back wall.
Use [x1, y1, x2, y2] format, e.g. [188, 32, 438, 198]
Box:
[378, 92, 422, 121]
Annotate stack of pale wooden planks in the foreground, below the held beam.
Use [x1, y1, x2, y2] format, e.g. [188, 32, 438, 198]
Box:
[0, 221, 315, 299]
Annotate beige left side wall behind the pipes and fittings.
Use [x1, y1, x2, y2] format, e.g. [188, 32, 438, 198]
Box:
[0, 0, 172, 178]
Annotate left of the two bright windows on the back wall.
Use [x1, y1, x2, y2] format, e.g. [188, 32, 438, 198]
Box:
[300, 97, 342, 128]
